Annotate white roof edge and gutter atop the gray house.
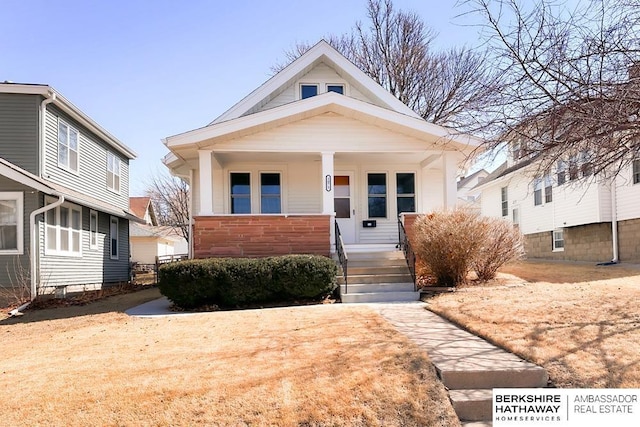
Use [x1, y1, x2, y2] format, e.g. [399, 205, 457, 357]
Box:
[0, 82, 136, 160]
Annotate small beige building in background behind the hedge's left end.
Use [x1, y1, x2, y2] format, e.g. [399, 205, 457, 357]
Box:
[129, 197, 187, 264]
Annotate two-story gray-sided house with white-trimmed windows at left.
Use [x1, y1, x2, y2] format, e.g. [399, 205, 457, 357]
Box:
[0, 83, 135, 298]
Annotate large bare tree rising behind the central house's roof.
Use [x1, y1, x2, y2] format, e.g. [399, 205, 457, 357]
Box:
[273, 0, 500, 131]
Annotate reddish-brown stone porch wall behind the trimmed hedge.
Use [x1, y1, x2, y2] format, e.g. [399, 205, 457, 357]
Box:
[193, 215, 331, 258]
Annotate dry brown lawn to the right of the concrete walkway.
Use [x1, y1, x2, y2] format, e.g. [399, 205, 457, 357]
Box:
[429, 262, 640, 388]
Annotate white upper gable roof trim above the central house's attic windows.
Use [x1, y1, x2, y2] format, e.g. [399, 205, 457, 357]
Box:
[209, 40, 420, 126]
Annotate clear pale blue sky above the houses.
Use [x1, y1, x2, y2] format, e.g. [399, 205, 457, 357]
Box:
[0, 0, 478, 196]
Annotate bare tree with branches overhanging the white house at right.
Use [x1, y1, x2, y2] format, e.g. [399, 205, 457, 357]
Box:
[460, 0, 640, 176]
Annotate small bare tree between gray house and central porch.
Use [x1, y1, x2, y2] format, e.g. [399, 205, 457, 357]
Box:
[146, 173, 189, 244]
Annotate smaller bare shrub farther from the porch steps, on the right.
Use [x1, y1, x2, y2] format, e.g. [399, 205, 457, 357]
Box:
[471, 218, 524, 282]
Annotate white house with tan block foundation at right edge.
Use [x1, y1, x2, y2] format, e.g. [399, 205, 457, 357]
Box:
[477, 145, 640, 262]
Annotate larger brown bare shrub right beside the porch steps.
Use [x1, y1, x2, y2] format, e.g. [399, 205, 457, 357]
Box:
[413, 209, 487, 287]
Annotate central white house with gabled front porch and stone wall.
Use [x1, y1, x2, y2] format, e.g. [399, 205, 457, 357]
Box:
[163, 41, 479, 257]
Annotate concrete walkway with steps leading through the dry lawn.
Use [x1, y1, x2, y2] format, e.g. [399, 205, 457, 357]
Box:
[368, 302, 548, 427]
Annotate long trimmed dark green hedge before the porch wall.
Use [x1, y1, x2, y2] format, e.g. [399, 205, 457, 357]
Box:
[158, 255, 337, 308]
